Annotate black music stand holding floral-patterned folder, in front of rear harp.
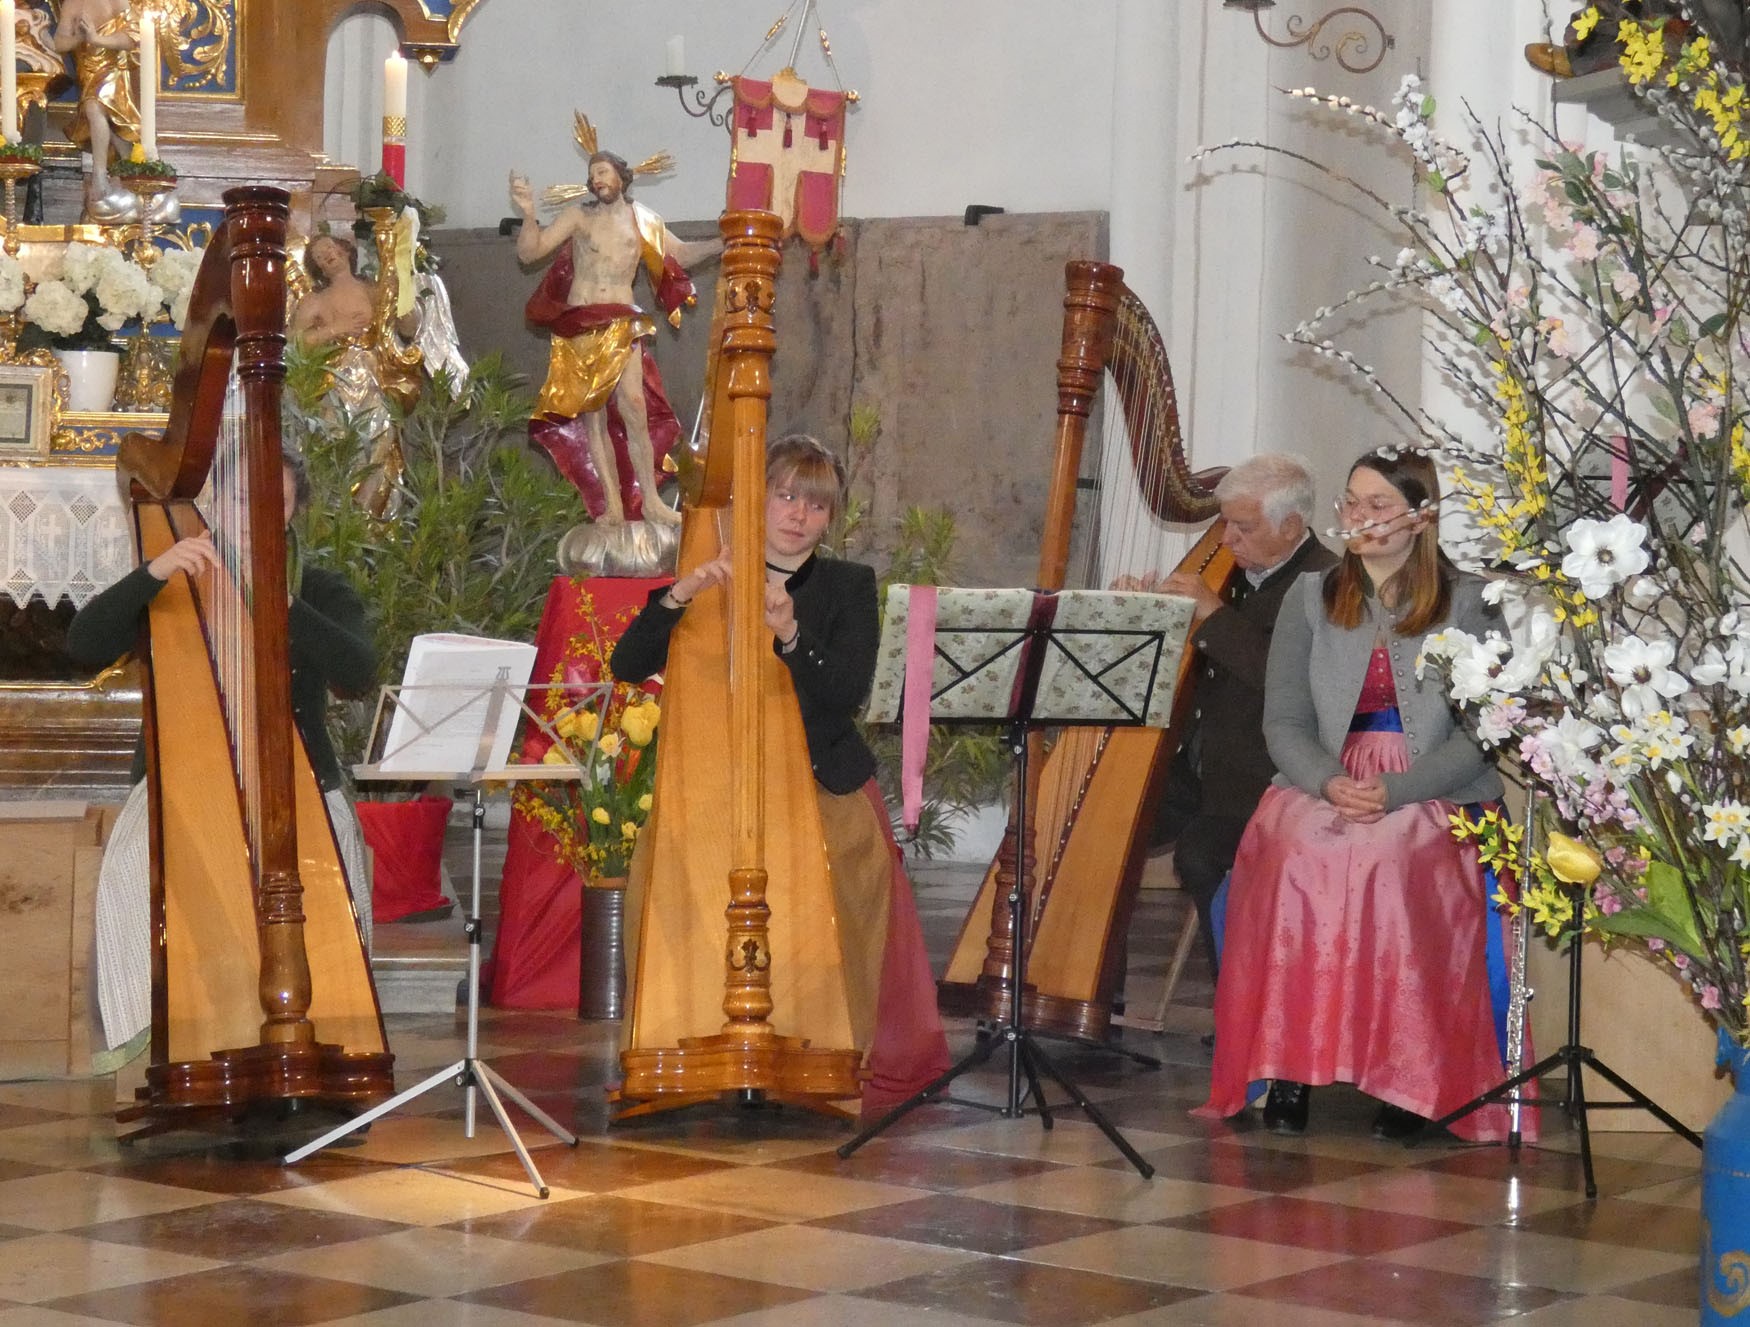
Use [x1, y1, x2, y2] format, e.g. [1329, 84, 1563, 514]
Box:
[838, 586, 1190, 1180]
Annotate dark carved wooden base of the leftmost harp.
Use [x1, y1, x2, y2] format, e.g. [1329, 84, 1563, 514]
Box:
[116, 1045, 396, 1124]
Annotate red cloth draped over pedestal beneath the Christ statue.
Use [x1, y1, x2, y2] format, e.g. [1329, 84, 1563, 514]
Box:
[480, 576, 669, 1010]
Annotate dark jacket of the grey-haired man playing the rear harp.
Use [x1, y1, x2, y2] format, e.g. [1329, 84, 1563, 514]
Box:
[1188, 537, 1337, 819]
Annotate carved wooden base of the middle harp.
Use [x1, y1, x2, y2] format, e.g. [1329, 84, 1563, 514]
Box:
[609, 1035, 863, 1120]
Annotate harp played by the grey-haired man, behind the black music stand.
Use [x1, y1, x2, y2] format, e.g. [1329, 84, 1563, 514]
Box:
[940, 263, 1234, 1040]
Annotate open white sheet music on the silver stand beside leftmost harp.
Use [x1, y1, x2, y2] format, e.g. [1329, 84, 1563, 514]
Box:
[378, 632, 536, 774]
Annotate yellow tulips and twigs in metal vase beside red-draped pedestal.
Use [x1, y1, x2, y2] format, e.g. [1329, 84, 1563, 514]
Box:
[513, 593, 662, 884]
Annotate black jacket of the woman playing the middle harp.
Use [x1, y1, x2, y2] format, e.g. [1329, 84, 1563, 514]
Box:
[609, 557, 880, 793]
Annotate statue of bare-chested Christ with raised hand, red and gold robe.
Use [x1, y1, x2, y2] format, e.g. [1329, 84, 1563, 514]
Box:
[511, 114, 723, 525]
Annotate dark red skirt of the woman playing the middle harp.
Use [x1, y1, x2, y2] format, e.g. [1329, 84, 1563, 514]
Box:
[863, 779, 949, 1120]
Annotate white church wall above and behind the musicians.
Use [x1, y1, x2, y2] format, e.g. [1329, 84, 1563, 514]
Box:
[327, 0, 1603, 556]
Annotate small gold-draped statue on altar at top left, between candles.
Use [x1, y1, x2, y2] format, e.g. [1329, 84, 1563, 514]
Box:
[54, 0, 140, 222]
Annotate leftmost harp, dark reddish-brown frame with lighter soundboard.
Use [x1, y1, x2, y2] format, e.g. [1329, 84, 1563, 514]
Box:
[117, 186, 394, 1129]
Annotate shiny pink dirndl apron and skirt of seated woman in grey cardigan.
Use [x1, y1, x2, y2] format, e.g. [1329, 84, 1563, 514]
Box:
[1194, 721, 1537, 1140]
